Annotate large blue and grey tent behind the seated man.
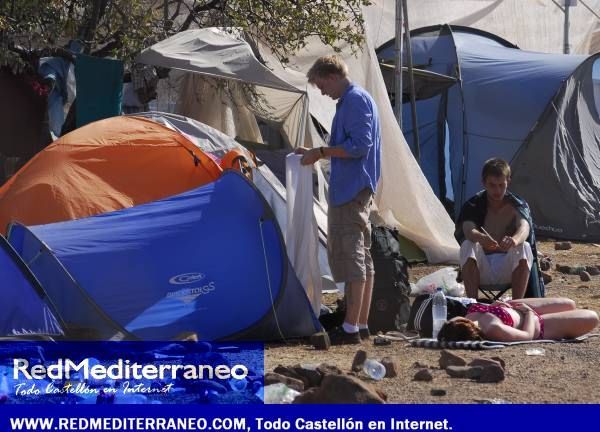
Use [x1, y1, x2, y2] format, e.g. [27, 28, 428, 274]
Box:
[378, 25, 600, 240]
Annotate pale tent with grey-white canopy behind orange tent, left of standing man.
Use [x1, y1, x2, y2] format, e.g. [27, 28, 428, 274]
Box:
[136, 28, 315, 147]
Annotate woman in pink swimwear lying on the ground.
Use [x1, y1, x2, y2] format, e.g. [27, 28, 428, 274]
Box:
[438, 298, 598, 342]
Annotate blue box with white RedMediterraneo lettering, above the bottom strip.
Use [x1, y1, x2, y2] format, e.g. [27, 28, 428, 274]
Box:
[0, 342, 264, 405]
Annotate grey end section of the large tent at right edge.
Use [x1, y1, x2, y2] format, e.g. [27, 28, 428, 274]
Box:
[511, 54, 600, 241]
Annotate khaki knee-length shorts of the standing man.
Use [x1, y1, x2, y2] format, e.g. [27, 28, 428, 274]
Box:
[327, 188, 375, 282]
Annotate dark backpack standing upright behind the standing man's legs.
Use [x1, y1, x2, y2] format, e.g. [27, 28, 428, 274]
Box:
[369, 226, 410, 333]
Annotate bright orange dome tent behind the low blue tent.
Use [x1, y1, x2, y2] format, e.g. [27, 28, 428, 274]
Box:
[0, 116, 223, 232]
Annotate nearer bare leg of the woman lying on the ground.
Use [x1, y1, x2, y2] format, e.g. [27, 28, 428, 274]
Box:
[542, 309, 598, 340]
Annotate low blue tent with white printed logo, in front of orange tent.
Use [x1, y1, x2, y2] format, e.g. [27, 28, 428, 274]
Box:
[9, 172, 320, 340]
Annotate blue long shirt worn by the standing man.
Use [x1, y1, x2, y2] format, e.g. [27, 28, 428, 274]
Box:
[329, 84, 381, 206]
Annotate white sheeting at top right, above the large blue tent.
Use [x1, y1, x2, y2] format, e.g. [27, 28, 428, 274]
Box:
[364, 0, 600, 54]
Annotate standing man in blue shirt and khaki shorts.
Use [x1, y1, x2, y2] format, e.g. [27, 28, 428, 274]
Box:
[296, 56, 381, 345]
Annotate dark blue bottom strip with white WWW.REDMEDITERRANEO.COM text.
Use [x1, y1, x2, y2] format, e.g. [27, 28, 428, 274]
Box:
[0, 405, 600, 432]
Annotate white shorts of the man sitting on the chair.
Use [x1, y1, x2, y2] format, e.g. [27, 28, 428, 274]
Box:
[460, 240, 533, 285]
